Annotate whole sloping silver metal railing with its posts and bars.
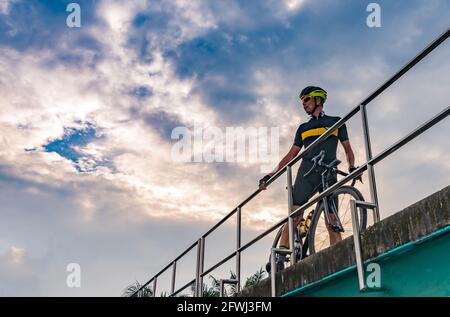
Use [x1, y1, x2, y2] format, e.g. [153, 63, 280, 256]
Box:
[132, 28, 450, 296]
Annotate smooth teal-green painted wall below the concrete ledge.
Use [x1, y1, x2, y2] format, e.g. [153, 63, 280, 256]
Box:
[285, 227, 450, 297]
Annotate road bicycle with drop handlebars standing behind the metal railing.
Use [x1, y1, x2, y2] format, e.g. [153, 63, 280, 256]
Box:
[266, 150, 367, 275]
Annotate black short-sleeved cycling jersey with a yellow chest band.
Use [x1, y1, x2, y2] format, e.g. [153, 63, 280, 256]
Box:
[294, 112, 348, 165]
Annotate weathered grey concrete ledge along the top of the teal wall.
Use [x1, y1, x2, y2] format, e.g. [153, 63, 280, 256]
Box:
[236, 186, 450, 297]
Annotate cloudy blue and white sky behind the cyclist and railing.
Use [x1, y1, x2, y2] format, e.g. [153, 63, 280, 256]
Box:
[0, 0, 450, 296]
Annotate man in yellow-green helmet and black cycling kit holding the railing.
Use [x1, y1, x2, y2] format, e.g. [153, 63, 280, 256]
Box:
[259, 86, 356, 269]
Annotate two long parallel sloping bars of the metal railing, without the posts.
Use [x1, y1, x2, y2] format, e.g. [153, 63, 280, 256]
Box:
[132, 27, 450, 296]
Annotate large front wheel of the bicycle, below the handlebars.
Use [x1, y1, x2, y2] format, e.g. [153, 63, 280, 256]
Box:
[308, 186, 367, 255]
